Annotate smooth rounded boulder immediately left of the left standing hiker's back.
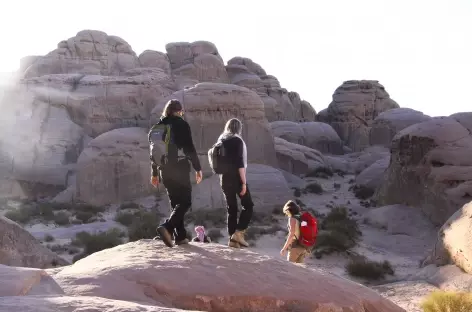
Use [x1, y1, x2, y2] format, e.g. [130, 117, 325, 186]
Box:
[76, 128, 152, 206]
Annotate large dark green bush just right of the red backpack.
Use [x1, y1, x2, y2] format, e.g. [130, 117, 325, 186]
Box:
[314, 207, 362, 257]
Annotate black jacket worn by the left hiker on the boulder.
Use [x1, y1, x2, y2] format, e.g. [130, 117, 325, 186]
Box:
[153, 116, 202, 171]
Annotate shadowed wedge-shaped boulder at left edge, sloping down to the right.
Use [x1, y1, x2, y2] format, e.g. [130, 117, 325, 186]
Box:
[0, 216, 69, 268]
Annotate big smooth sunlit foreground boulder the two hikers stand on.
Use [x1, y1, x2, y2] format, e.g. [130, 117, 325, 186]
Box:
[54, 240, 404, 312]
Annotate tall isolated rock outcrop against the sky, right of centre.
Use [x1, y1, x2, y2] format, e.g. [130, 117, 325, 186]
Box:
[319, 80, 399, 152]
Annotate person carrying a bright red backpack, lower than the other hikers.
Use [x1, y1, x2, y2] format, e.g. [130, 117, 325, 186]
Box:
[280, 200, 318, 263]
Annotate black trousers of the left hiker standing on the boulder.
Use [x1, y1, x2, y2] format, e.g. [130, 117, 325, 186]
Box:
[161, 160, 192, 241]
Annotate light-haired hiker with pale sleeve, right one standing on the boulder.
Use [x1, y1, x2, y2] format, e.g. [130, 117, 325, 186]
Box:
[218, 118, 254, 248]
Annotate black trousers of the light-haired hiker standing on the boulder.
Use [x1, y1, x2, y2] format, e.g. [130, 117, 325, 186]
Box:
[220, 173, 254, 237]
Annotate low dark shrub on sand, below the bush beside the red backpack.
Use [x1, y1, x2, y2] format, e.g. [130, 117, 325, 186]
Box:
[346, 257, 395, 280]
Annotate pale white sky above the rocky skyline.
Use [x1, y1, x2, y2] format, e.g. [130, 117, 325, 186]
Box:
[0, 0, 472, 116]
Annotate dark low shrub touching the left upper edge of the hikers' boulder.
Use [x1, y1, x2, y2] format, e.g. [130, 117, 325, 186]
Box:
[72, 228, 123, 262]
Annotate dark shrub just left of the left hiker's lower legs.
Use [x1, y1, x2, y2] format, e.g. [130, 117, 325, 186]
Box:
[128, 211, 160, 242]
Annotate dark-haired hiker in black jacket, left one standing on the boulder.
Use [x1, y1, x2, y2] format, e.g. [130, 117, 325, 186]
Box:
[148, 99, 202, 247]
